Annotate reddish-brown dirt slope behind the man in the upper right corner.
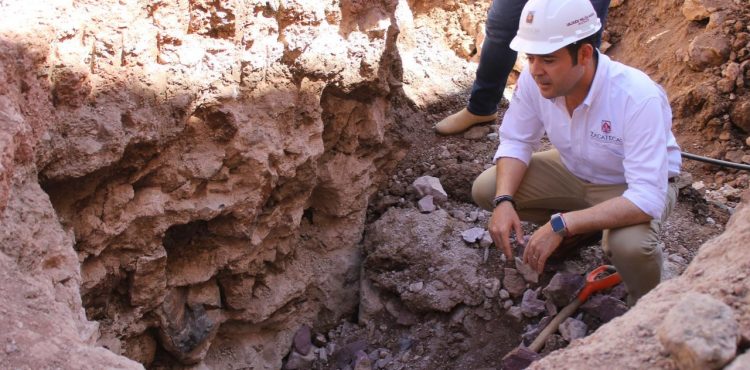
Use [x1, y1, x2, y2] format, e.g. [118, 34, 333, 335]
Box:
[607, 0, 750, 141]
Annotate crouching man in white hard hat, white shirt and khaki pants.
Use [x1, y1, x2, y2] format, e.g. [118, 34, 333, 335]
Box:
[472, 0, 681, 304]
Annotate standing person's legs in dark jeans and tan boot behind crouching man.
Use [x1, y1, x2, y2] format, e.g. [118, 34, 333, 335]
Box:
[435, 0, 610, 135]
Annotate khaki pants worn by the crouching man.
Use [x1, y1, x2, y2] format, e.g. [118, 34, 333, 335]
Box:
[471, 150, 677, 304]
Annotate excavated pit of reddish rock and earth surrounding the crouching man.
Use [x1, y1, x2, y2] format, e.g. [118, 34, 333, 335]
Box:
[0, 0, 750, 369]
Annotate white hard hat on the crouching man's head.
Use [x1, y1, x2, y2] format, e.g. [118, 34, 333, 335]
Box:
[510, 0, 602, 55]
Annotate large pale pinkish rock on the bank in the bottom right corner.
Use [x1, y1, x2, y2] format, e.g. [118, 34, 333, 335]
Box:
[657, 292, 740, 370]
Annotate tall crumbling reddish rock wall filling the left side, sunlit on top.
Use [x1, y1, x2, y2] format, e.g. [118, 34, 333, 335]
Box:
[0, 0, 488, 368]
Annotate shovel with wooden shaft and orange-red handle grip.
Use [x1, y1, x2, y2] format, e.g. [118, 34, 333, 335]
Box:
[502, 265, 622, 368]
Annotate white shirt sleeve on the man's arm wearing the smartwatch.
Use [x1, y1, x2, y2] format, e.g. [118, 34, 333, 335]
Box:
[623, 97, 671, 220]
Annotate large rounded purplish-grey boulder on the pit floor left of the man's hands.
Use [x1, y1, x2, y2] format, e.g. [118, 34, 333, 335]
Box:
[360, 208, 488, 312]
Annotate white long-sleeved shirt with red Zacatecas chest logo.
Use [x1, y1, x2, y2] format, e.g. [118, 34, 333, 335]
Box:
[494, 53, 682, 219]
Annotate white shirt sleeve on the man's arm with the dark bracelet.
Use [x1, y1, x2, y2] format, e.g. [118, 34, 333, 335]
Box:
[493, 70, 544, 165]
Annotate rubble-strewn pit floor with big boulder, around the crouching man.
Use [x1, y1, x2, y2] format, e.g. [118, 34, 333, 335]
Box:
[280, 94, 739, 369]
